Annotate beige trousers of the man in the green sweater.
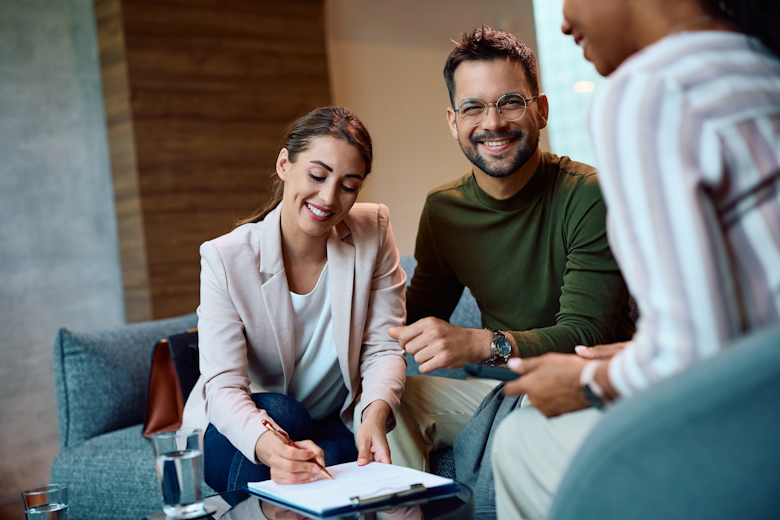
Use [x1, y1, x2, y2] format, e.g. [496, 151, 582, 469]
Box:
[387, 376, 499, 472]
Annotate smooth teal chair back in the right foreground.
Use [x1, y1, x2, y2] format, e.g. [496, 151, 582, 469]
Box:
[548, 325, 780, 520]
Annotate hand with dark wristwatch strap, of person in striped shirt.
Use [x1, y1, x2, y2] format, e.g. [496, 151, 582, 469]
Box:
[504, 353, 590, 417]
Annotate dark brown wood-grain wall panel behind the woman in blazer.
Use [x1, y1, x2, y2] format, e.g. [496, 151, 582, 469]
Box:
[96, 0, 330, 321]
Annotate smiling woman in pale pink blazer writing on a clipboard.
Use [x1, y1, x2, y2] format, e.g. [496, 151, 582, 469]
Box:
[183, 107, 406, 492]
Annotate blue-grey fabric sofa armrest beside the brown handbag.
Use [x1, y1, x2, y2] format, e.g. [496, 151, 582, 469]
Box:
[54, 313, 198, 448]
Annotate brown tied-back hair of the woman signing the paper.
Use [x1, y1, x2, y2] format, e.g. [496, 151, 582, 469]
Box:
[236, 106, 374, 226]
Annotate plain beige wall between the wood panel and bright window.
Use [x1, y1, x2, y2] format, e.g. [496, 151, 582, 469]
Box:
[325, 0, 546, 254]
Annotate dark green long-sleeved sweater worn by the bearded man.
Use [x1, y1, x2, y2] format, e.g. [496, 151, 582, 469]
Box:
[406, 153, 634, 357]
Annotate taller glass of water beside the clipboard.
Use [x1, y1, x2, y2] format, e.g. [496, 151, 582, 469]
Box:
[152, 428, 206, 518]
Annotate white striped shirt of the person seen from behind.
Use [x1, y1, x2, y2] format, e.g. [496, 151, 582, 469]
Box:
[590, 31, 780, 396]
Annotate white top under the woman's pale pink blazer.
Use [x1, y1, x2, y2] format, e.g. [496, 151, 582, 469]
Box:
[288, 263, 348, 419]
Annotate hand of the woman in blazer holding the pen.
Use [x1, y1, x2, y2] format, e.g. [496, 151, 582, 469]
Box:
[255, 422, 325, 484]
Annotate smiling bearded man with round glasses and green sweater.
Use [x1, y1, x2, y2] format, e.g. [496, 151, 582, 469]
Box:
[388, 27, 634, 518]
